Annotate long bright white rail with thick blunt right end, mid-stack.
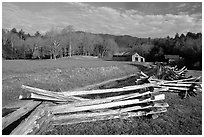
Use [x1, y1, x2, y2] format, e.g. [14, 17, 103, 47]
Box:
[48, 94, 165, 114]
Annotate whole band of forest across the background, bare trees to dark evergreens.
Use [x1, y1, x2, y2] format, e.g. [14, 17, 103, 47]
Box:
[2, 25, 202, 70]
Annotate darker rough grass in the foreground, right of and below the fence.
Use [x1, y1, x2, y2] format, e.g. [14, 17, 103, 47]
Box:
[44, 93, 202, 135]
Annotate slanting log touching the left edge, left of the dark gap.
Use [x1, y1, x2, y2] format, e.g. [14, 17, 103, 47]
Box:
[2, 101, 41, 130]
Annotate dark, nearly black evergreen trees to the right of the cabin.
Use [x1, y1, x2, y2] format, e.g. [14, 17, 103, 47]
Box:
[146, 32, 202, 70]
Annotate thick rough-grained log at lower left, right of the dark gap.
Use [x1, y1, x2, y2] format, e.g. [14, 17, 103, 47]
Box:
[11, 103, 50, 135]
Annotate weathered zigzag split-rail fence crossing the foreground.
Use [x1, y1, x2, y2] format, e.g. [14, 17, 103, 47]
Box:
[2, 65, 201, 135]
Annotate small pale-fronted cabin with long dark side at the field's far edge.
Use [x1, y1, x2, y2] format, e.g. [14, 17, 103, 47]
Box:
[113, 52, 145, 62]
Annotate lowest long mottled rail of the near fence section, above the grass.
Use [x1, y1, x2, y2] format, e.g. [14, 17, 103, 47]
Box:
[52, 108, 167, 125]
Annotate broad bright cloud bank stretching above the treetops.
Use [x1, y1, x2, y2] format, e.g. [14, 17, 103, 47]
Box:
[2, 3, 202, 37]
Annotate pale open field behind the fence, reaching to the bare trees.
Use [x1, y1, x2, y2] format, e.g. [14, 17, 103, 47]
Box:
[2, 56, 138, 106]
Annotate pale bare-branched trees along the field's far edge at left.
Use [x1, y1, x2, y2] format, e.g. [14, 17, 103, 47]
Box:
[2, 26, 118, 59]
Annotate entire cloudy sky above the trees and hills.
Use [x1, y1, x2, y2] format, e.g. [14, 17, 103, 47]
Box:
[2, 2, 202, 38]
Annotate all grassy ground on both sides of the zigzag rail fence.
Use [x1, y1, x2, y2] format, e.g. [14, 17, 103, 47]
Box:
[2, 57, 202, 135]
